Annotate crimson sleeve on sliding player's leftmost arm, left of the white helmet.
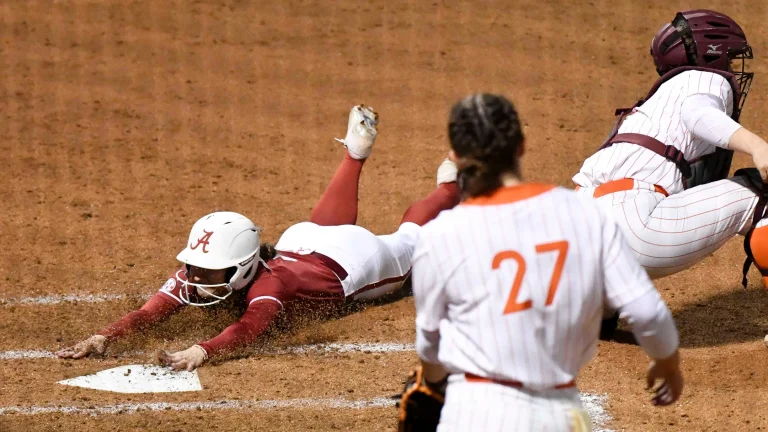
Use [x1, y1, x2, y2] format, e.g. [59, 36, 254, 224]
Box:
[98, 270, 184, 339]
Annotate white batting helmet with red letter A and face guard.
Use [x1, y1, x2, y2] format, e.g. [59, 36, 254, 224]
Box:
[176, 212, 261, 306]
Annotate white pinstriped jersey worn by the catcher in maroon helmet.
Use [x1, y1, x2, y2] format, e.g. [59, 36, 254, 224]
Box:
[573, 70, 733, 194]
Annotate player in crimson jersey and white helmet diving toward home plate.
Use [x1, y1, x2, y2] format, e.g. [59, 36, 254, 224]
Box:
[57, 105, 459, 371]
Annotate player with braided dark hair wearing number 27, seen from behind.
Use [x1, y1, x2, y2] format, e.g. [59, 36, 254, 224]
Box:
[412, 94, 683, 432]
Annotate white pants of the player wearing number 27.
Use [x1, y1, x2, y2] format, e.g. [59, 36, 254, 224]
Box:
[437, 375, 592, 432]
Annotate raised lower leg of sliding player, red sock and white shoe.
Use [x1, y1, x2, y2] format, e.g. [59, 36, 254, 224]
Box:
[309, 105, 378, 226]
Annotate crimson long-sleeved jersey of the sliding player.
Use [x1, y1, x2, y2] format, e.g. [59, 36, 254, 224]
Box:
[99, 252, 346, 356]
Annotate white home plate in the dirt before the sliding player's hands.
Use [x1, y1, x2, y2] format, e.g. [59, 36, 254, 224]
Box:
[58, 365, 203, 393]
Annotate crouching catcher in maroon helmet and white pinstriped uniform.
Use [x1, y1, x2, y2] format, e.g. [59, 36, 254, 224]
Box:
[573, 10, 768, 286]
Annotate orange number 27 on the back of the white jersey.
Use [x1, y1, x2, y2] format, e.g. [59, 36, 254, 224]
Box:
[491, 241, 568, 315]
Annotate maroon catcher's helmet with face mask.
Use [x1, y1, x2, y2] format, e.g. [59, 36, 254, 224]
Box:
[651, 9, 754, 116]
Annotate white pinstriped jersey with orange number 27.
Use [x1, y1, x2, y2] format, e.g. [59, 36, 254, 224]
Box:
[413, 184, 654, 389]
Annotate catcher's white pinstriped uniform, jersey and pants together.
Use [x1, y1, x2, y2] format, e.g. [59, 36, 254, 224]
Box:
[573, 71, 757, 277]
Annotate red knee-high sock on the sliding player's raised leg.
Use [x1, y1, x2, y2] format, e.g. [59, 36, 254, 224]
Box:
[309, 153, 365, 226]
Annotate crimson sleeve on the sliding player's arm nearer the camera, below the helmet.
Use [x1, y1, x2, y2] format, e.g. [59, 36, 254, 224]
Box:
[198, 270, 290, 357]
